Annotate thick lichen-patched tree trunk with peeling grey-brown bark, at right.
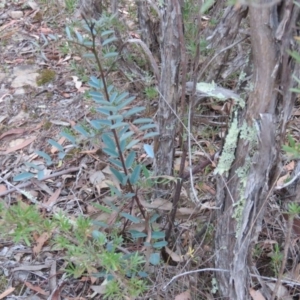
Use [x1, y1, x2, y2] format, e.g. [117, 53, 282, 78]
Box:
[215, 0, 298, 300]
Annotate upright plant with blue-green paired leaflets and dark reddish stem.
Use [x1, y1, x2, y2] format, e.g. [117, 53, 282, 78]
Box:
[14, 19, 158, 218]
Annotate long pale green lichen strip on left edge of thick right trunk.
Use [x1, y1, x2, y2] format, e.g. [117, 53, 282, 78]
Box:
[215, 113, 240, 174]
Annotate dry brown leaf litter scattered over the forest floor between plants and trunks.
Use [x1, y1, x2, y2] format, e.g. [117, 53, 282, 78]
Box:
[0, 0, 299, 300]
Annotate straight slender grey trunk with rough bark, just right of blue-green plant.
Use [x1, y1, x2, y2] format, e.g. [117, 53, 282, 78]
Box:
[154, 0, 181, 175]
